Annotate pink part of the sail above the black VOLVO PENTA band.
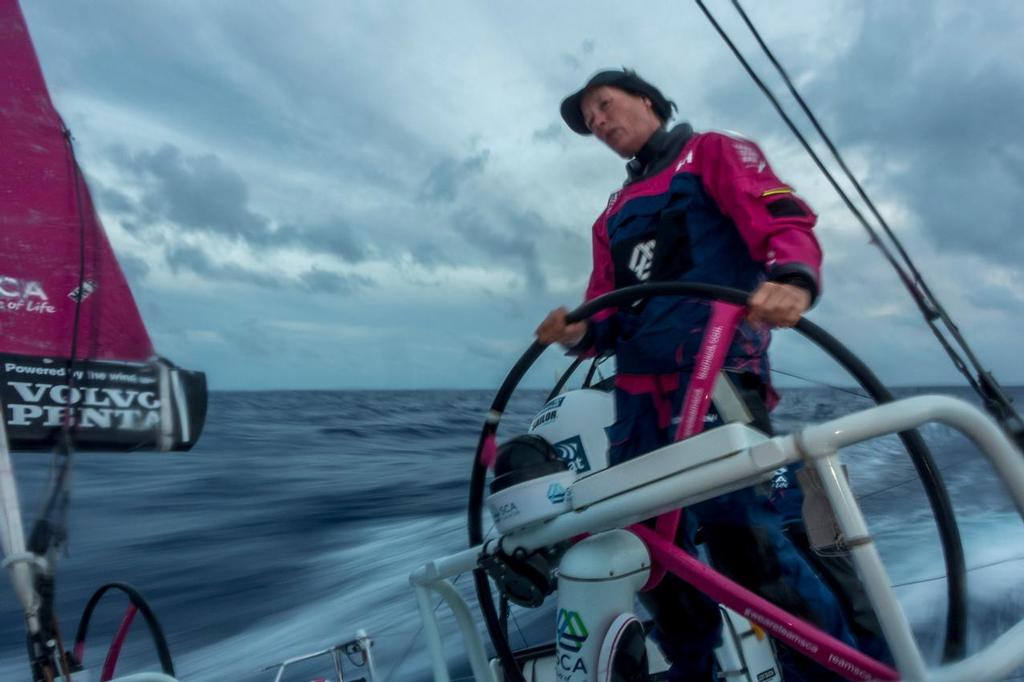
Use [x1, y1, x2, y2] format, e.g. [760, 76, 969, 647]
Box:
[0, 0, 154, 360]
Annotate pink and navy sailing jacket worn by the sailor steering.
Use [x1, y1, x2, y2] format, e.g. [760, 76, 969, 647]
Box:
[578, 124, 821, 376]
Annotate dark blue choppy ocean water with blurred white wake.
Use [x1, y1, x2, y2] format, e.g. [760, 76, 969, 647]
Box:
[0, 388, 1024, 682]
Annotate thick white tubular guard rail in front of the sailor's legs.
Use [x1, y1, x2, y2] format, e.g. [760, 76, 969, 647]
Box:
[410, 395, 1024, 682]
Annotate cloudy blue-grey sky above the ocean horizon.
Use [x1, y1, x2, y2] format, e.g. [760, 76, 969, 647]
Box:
[23, 0, 1024, 389]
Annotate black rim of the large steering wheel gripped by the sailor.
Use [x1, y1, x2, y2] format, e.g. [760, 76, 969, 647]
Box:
[469, 282, 967, 682]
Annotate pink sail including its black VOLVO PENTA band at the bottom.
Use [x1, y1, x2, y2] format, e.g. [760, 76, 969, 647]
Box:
[0, 0, 206, 451]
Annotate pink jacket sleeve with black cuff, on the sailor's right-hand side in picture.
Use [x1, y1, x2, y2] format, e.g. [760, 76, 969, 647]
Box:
[693, 133, 821, 297]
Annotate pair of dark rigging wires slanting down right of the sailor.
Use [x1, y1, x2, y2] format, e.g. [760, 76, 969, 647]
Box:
[695, 0, 1024, 443]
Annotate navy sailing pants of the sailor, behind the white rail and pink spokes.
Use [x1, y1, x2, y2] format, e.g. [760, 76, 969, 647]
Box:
[607, 380, 853, 680]
